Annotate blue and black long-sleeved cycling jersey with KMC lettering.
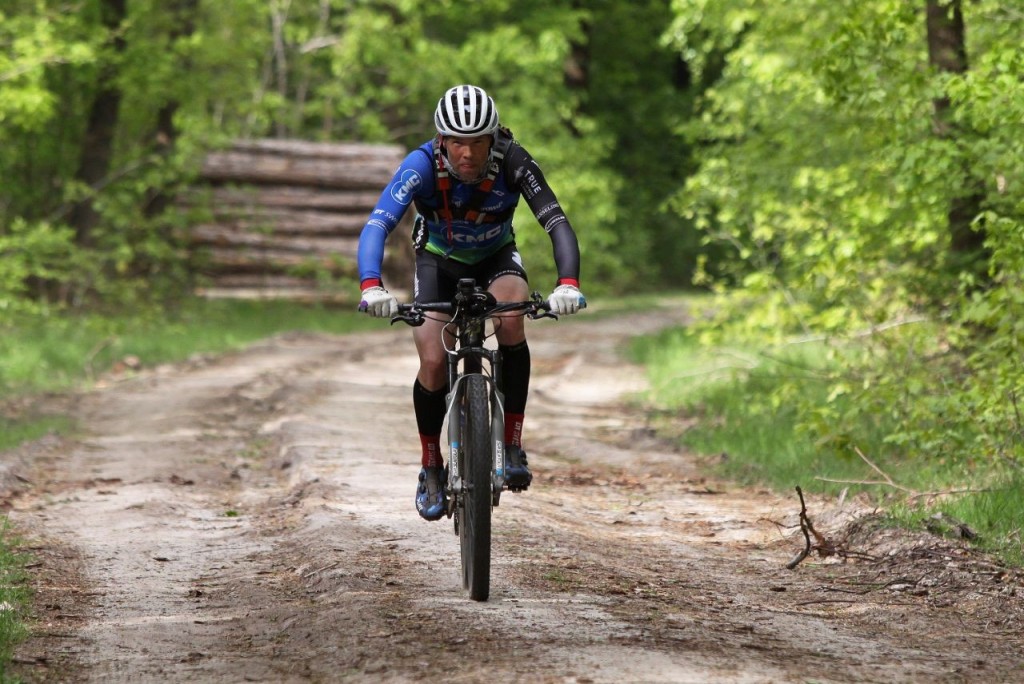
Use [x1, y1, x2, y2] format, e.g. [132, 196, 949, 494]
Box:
[358, 132, 580, 284]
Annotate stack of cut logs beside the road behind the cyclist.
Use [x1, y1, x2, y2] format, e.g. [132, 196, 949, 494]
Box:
[187, 140, 412, 300]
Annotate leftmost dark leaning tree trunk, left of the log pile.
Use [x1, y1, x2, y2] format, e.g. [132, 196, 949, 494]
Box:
[70, 0, 126, 247]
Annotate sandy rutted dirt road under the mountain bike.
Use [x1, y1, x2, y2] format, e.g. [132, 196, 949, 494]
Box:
[4, 305, 1024, 683]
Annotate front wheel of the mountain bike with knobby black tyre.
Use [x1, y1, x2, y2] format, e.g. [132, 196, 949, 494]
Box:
[459, 375, 492, 601]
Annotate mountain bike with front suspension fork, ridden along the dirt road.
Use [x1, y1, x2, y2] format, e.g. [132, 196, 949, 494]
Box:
[391, 279, 558, 601]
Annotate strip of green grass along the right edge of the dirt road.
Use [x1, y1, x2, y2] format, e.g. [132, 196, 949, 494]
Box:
[632, 330, 1024, 565]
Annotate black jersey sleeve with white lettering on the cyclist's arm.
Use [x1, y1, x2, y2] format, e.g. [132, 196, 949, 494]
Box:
[506, 143, 580, 282]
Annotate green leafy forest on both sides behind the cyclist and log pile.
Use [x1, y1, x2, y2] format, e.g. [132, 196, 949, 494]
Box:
[0, 0, 1024, 511]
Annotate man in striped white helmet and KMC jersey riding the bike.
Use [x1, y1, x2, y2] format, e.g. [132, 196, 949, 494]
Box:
[358, 85, 586, 520]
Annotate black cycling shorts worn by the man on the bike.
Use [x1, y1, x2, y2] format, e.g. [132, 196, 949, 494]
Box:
[413, 243, 529, 303]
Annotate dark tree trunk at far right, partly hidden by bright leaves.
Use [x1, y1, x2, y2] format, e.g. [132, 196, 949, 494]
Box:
[926, 0, 987, 275]
